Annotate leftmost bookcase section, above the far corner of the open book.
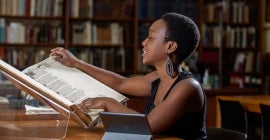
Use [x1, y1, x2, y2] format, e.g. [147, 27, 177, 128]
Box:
[0, 0, 65, 69]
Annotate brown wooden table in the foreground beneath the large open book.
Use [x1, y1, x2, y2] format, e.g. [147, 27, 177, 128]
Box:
[0, 104, 181, 140]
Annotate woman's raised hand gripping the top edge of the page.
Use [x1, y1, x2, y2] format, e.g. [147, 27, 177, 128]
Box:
[50, 47, 80, 67]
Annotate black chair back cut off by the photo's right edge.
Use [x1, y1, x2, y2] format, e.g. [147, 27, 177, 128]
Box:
[260, 104, 270, 140]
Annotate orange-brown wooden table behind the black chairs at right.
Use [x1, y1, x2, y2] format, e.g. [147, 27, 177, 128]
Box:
[216, 95, 270, 127]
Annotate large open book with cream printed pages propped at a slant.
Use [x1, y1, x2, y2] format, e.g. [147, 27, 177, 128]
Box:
[0, 57, 128, 128]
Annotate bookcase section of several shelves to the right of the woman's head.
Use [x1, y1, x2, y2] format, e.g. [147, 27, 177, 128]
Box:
[200, 0, 262, 89]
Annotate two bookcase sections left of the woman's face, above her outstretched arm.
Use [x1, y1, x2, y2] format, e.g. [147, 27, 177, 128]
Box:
[0, 0, 135, 74]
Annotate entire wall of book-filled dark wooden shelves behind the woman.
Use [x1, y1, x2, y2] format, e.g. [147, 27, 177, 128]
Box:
[0, 0, 270, 92]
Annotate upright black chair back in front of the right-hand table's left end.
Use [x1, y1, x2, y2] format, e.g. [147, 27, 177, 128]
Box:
[219, 99, 248, 134]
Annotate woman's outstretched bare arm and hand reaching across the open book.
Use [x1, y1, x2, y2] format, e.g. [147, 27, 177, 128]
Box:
[50, 47, 157, 96]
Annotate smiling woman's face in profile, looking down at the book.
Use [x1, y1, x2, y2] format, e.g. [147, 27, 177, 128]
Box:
[142, 19, 169, 66]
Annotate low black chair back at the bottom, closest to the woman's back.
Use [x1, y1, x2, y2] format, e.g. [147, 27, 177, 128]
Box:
[206, 127, 247, 140]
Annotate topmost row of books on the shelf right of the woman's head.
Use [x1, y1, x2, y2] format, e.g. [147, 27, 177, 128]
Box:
[204, 1, 255, 23]
